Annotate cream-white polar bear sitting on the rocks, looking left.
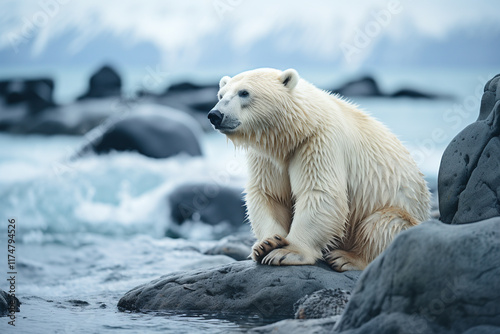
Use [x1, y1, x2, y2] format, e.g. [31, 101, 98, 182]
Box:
[208, 69, 430, 271]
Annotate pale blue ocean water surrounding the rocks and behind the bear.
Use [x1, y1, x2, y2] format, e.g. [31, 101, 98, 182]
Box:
[0, 67, 494, 333]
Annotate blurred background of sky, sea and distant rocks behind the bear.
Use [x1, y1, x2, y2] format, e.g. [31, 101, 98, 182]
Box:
[0, 0, 500, 332]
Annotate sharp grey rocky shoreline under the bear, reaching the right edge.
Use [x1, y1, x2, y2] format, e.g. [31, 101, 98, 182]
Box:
[118, 75, 500, 333]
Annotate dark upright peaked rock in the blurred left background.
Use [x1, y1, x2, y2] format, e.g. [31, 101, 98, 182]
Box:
[78, 65, 122, 100]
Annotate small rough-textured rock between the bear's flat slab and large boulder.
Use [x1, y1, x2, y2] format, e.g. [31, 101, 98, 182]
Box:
[293, 288, 351, 319]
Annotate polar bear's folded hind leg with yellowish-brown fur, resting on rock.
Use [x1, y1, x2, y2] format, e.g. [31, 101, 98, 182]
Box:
[324, 207, 418, 272]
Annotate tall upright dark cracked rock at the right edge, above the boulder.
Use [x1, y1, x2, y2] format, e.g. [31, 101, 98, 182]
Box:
[438, 74, 500, 224]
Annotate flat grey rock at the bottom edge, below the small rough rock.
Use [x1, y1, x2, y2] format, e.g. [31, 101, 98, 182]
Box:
[248, 315, 340, 334]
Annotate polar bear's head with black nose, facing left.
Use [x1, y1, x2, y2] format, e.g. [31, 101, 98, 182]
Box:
[208, 69, 301, 144]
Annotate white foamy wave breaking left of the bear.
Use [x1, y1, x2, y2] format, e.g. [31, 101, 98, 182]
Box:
[0, 137, 244, 241]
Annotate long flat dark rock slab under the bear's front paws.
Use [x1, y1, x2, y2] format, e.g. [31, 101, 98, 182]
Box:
[118, 261, 359, 320]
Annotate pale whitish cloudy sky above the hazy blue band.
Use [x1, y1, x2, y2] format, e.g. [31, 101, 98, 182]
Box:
[0, 0, 500, 68]
